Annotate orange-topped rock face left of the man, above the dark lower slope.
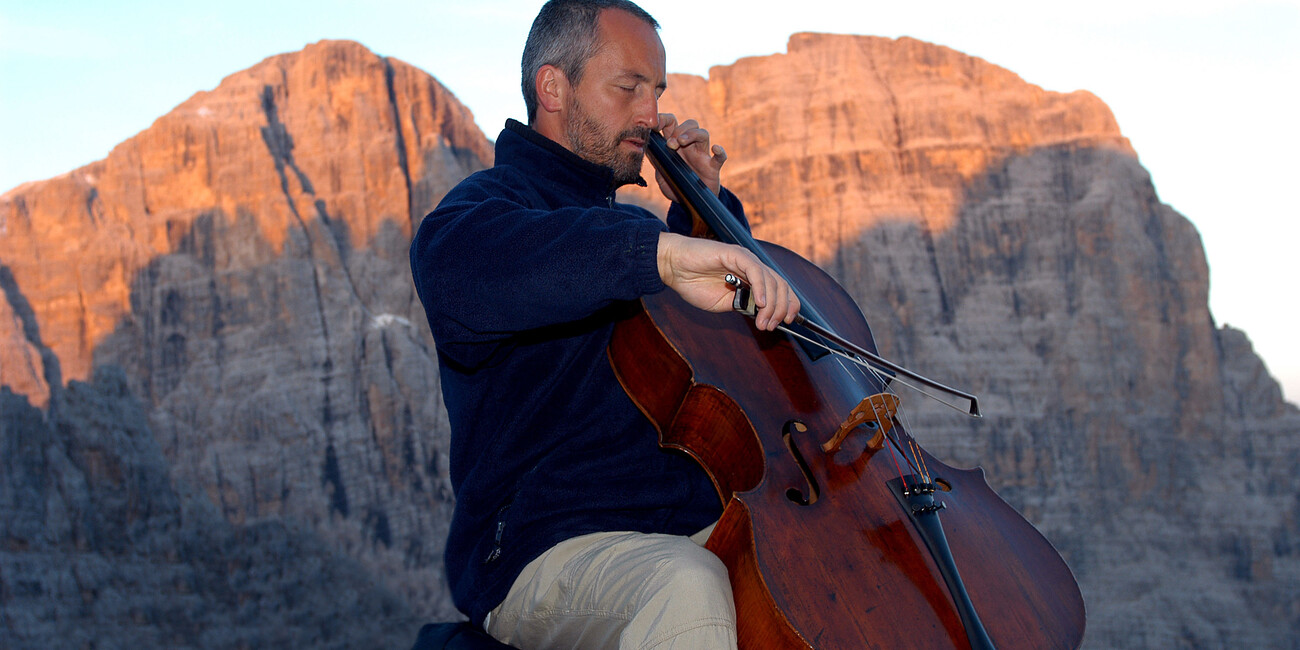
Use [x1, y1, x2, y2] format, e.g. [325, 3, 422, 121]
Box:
[0, 42, 491, 647]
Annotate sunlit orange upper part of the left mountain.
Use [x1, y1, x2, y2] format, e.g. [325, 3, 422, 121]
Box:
[0, 40, 491, 402]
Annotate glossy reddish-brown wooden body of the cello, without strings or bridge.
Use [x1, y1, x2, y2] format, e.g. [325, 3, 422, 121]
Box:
[610, 244, 1084, 650]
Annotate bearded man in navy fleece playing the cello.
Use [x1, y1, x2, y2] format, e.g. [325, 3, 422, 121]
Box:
[411, 0, 798, 649]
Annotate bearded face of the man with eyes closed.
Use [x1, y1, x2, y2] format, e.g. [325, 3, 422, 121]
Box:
[564, 9, 668, 183]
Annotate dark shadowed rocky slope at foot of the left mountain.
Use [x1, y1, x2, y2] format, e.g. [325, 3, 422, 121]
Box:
[0, 367, 421, 650]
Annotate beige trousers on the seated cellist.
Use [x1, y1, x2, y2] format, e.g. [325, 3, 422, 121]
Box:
[484, 527, 736, 650]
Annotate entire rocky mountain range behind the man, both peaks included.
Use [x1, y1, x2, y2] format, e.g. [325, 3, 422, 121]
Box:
[0, 34, 1300, 647]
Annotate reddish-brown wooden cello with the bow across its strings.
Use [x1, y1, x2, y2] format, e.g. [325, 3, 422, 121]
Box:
[608, 133, 1086, 650]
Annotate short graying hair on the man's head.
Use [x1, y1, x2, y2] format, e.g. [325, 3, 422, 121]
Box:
[520, 0, 659, 124]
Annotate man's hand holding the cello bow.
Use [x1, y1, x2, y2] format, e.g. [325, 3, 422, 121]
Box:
[658, 233, 800, 330]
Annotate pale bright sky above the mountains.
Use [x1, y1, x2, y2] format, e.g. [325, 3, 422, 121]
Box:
[0, 0, 1300, 403]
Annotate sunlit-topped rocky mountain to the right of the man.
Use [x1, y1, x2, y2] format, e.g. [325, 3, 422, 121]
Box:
[624, 34, 1300, 647]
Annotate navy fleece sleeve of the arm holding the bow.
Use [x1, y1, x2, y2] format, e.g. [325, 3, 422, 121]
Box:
[411, 179, 666, 347]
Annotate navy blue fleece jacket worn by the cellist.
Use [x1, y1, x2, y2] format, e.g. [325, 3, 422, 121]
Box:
[411, 120, 744, 624]
